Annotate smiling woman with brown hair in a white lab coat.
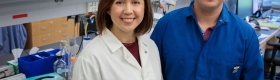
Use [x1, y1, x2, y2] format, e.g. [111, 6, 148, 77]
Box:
[72, 0, 162, 80]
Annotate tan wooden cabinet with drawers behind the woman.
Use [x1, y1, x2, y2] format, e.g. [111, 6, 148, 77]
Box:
[24, 17, 79, 49]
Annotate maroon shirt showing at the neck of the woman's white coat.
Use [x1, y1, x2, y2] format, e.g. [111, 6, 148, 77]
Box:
[123, 39, 141, 66]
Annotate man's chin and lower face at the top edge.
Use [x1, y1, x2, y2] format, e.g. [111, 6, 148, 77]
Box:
[195, 0, 224, 9]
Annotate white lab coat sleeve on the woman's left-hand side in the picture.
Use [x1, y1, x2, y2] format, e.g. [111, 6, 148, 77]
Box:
[72, 57, 102, 80]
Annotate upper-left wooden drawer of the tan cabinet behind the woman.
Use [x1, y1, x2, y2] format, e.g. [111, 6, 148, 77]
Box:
[31, 19, 57, 36]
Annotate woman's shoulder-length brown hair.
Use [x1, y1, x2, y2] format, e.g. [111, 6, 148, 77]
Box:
[96, 0, 153, 36]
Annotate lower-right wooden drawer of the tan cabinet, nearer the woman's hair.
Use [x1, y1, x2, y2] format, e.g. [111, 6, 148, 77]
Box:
[55, 27, 74, 42]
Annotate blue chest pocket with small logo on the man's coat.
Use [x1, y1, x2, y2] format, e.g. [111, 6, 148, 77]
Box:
[214, 61, 243, 80]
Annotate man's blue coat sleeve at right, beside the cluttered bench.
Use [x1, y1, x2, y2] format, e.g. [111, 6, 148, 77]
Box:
[240, 32, 264, 80]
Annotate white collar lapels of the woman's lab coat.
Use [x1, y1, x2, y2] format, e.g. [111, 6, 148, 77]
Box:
[101, 28, 149, 71]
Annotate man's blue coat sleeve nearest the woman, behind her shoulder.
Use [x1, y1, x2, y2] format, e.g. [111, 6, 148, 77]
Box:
[151, 17, 168, 78]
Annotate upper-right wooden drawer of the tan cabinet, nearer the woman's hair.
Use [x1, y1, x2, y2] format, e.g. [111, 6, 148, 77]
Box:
[55, 17, 74, 30]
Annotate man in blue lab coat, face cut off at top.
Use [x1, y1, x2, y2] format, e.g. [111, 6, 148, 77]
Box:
[151, 0, 264, 80]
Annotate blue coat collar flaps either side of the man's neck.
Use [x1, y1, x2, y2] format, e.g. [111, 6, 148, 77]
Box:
[185, 1, 229, 22]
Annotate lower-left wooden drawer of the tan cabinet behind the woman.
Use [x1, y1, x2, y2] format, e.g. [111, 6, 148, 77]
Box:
[32, 32, 54, 47]
